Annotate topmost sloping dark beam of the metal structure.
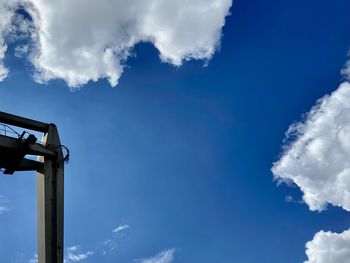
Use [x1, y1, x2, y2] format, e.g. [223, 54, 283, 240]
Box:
[0, 111, 49, 133]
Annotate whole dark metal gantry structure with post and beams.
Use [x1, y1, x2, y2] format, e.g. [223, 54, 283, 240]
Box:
[0, 112, 65, 263]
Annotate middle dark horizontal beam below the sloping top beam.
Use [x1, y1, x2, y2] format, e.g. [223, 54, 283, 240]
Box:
[0, 135, 57, 158]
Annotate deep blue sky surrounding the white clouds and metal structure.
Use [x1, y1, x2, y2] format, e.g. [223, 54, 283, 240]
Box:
[0, 0, 350, 263]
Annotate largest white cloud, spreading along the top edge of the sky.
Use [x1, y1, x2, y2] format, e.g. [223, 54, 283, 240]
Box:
[0, 0, 232, 87]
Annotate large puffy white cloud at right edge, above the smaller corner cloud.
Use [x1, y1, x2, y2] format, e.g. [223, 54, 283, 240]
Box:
[272, 82, 350, 211]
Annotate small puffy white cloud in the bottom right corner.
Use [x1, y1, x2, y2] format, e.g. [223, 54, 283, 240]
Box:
[304, 230, 350, 263]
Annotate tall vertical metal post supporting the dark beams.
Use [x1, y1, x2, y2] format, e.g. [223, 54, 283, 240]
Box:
[37, 124, 64, 263]
